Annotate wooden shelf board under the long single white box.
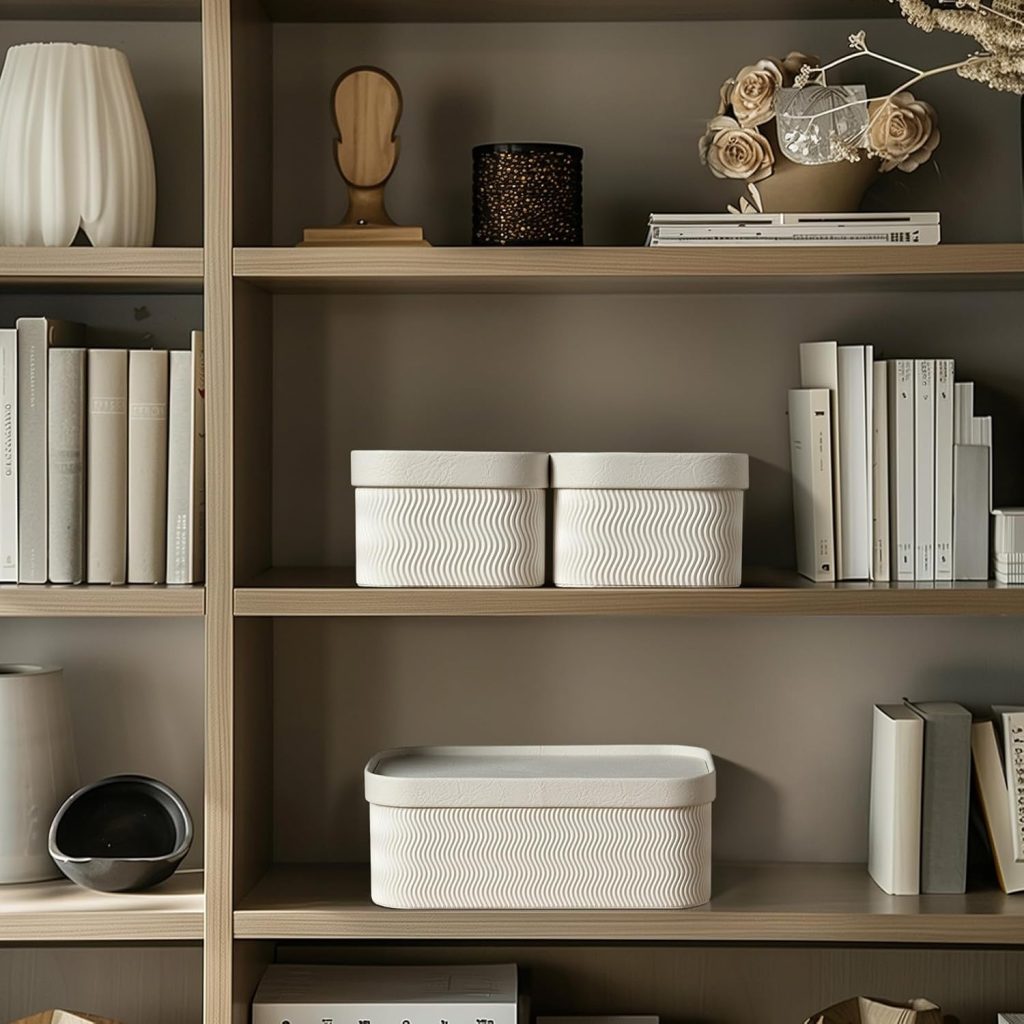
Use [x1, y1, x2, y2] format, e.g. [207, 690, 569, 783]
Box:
[234, 864, 1024, 946]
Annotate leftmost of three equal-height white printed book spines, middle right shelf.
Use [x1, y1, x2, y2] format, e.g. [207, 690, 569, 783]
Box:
[889, 359, 914, 581]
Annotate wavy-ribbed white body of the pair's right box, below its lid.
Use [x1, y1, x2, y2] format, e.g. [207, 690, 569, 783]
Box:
[554, 488, 743, 587]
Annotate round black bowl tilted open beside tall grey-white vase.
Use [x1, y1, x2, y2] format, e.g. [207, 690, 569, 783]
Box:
[49, 775, 193, 893]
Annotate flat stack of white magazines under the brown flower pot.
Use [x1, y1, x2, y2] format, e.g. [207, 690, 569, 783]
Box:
[646, 213, 939, 246]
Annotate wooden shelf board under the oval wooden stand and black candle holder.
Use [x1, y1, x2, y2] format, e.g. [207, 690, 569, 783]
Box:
[234, 244, 1024, 292]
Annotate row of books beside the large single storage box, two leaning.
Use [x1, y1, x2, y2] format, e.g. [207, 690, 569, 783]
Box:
[867, 700, 1024, 896]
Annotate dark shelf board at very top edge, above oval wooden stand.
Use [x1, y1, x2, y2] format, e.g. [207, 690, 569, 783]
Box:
[258, 0, 894, 22]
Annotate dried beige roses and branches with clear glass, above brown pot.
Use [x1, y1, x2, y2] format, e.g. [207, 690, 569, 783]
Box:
[698, 0, 1024, 212]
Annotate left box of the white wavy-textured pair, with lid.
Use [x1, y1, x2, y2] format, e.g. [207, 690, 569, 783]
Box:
[352, 452, 548, 587]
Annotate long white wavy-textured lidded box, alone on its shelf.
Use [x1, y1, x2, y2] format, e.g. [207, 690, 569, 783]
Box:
[366, 746, 715, 909]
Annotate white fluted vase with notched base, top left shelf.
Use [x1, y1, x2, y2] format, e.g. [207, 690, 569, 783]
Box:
[0, 43, 157, 246]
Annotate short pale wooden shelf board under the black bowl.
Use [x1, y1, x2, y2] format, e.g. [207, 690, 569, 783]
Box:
[0, 870, 203, 942]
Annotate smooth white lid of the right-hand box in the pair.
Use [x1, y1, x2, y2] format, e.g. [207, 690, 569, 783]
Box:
[551, 452, 750, 490]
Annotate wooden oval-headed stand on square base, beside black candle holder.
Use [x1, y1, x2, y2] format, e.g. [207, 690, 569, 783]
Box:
[301, 68, 430, 246]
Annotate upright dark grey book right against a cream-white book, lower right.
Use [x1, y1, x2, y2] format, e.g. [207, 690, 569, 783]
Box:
[910, 701, 971, 893]
